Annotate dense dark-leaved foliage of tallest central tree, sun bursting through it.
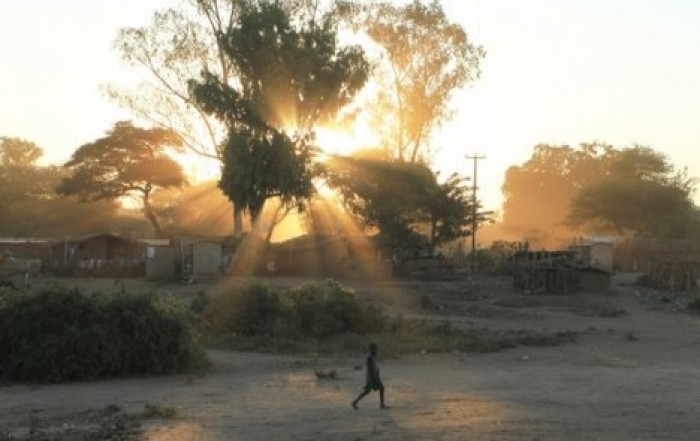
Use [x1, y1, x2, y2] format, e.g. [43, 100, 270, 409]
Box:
[190, 1, 368, 230]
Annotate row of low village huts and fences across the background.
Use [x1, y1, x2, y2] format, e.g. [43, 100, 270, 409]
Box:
[0, 233, 700, 294]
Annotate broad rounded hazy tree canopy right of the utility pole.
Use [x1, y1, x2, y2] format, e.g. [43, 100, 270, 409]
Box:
[502, 143, 694, 244]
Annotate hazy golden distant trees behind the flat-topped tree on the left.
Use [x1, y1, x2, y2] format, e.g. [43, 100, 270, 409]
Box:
[0, 137, 232, 237]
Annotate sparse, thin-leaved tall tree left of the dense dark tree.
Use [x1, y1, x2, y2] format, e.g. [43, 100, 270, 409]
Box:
[107, 0, 346, 234]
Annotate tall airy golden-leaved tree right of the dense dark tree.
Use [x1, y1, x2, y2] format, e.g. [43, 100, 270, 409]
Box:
[341, 0, 485, 162]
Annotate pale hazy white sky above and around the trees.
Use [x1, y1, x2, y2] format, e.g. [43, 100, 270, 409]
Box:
[0, 0, 700, 208]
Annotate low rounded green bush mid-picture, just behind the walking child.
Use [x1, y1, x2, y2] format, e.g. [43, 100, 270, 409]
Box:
[203, 280, 384, 343]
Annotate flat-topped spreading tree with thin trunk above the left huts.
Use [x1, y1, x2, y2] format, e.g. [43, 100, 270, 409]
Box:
[58, 122, 186, 237]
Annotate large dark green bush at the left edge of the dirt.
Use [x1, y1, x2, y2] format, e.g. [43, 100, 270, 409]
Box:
[0, 287, 206, 381]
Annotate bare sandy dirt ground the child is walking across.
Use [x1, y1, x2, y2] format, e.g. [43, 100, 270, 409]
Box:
[0, 277, 700, 441]
